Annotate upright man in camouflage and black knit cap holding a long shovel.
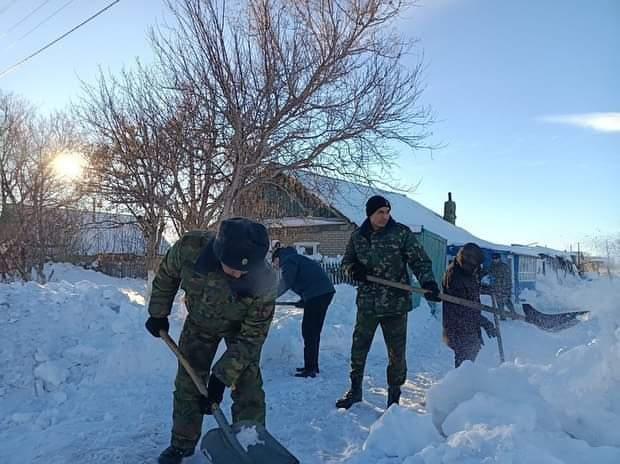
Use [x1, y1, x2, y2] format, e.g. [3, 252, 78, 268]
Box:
[336, 195, 440, 409]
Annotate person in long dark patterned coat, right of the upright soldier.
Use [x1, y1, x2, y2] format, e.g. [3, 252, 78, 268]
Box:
[443, 243, 497, 367]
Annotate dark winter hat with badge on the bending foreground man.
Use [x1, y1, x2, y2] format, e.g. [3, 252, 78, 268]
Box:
[213, 217, 269, 272]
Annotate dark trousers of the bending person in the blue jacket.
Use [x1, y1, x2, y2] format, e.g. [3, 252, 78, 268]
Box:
[301, 293, 334, 370]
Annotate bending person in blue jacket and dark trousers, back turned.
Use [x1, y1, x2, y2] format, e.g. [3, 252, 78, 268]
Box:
[271, 247, 336, 377]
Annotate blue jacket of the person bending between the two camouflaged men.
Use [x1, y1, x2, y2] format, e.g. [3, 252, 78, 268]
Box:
[278, 247, 335, 301]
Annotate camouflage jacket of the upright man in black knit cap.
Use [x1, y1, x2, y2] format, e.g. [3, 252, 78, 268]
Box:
[342, 218, 435, 315]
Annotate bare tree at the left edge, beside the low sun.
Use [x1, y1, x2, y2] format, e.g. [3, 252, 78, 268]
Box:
[0, 96, 82, 282]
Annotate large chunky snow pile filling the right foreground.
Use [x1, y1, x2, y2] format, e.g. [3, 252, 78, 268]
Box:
[355, 280, 620, 464]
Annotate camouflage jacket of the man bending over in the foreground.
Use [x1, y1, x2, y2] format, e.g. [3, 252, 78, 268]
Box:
[149, 231, 276, 386]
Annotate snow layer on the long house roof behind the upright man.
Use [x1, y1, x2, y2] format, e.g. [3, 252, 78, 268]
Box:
[296, 173, 568, 257]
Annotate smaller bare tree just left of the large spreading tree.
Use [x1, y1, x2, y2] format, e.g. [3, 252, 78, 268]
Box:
[76, 63, 174, 276]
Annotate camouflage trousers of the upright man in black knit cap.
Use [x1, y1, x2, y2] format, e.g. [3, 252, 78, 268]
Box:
[351, 310, 407, 387]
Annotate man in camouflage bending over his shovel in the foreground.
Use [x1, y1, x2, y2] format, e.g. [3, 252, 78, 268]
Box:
[146, 218, 276, 464]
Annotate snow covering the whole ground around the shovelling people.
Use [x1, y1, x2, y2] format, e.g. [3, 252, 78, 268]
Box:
[0, 265, 620, 464]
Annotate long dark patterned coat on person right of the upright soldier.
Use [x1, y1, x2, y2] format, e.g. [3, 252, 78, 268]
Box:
[443, 260, 492, 350]
